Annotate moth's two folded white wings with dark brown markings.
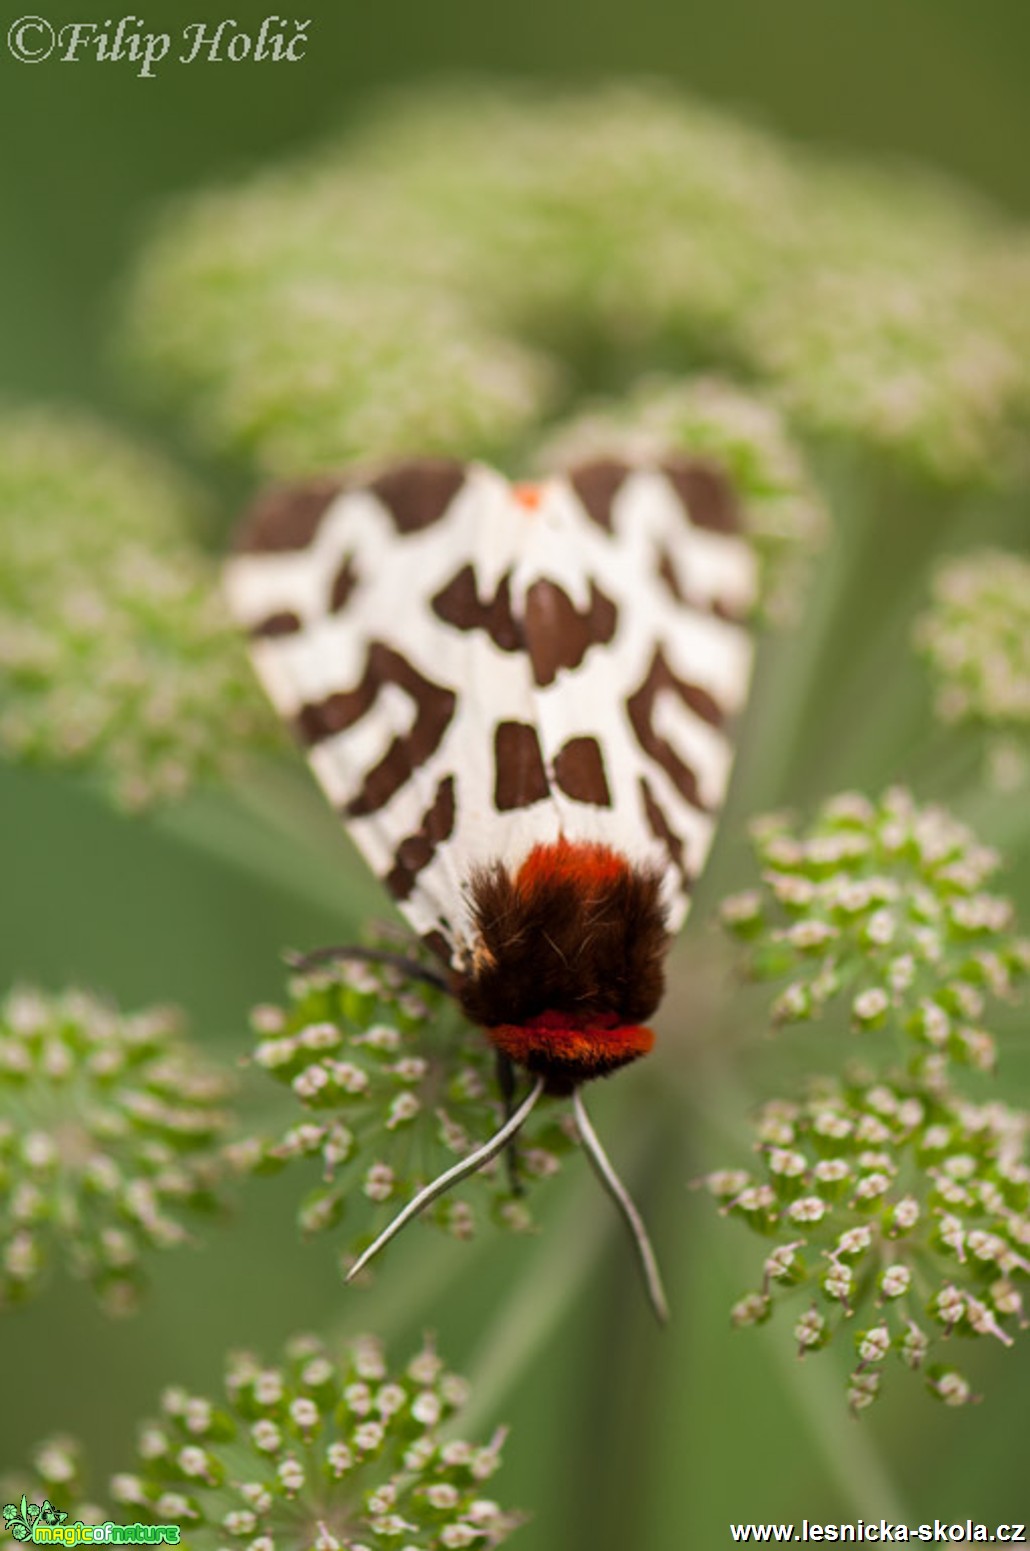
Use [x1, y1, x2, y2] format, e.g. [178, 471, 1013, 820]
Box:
[226, 461, 754, 960]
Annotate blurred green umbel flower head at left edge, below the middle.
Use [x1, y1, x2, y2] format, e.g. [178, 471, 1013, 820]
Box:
[0, 990, 226, 1314]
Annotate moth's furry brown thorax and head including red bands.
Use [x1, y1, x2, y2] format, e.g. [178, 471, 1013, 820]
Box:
[458, 839, 669, 1087]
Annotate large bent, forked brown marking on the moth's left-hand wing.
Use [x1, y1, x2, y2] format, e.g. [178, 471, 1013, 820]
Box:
[296, 641, 458, 819]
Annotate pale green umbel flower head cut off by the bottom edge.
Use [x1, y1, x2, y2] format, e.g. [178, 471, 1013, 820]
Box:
[110, 1335, 518, 1551]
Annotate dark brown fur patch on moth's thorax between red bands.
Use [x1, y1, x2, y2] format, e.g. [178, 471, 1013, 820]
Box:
[456, 862, 669, 1028]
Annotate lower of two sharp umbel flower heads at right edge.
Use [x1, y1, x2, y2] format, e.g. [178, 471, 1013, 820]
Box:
[707, 1073, 1030, 1410]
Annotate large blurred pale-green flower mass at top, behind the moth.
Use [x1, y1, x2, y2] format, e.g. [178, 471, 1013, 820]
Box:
[129, 84, 1030, 484]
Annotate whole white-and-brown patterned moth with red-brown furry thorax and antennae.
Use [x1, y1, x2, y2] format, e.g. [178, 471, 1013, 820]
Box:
[226, 456, 757, 1317]
